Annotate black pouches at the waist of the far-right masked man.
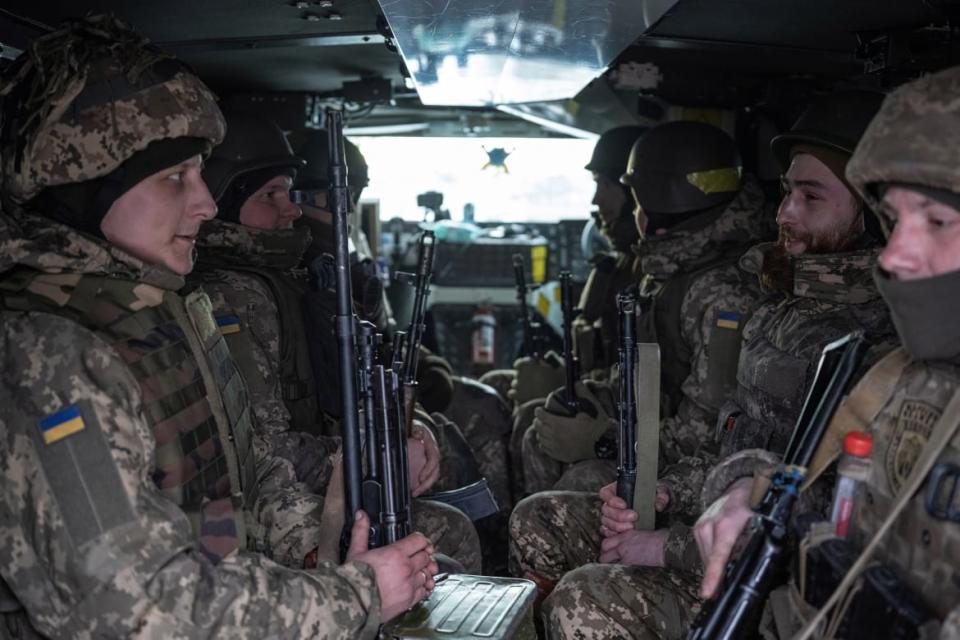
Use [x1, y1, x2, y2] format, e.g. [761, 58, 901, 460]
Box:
[770, 518, 937, 640]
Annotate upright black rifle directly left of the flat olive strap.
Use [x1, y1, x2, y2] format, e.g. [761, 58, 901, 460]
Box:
[617, 291, 637, 505]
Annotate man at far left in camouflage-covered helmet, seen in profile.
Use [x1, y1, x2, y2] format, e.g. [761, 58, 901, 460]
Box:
[0, 16, 436, 638]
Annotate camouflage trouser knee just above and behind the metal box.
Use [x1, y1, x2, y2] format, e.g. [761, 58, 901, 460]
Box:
[411, 500, 481, 574]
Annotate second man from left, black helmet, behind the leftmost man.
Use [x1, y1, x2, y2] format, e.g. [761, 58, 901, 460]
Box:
[191, 114, 480, 573]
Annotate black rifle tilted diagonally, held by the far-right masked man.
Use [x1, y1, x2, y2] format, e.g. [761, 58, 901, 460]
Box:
[687, 331, 866, 640]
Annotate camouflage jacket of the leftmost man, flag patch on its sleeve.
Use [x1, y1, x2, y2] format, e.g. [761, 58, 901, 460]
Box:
[0, 216, 379, 638]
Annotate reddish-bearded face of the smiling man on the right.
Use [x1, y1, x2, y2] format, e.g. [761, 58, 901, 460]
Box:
[777, 153, 863, 255]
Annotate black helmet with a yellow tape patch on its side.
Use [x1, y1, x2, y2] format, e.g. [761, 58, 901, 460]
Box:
[620, 121, 742, 214]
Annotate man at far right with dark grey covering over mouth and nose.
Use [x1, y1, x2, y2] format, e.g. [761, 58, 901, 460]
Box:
[696, 67, 960, 639]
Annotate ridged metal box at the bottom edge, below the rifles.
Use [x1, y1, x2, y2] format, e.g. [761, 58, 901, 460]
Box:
[381, 575, 537, 640]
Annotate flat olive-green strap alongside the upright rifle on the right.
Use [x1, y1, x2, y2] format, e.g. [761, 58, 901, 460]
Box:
[633, 342, 660, 531]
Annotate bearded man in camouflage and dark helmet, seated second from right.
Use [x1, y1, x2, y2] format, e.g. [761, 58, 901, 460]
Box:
[536, 92, 892, 637]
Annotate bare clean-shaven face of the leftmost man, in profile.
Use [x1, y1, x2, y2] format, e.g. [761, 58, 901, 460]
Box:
[100, 156, 217, 275]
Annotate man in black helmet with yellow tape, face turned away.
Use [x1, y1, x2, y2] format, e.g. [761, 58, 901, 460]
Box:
[523, 122, 769, 493]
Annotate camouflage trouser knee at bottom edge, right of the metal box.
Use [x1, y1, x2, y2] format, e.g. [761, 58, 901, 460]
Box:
[542, 564, 700, 640]
